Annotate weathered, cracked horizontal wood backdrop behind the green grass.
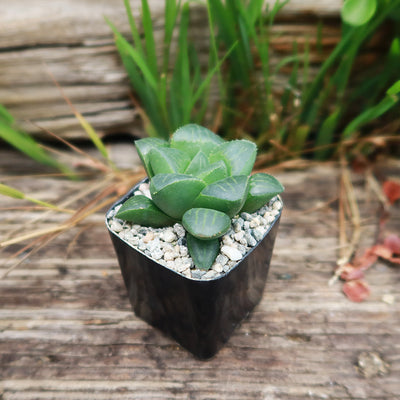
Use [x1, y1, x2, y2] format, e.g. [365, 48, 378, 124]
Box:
[0, 0, 341, 139]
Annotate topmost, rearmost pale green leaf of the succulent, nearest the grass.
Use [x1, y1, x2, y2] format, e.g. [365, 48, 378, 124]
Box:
[171, 124, 224, 158]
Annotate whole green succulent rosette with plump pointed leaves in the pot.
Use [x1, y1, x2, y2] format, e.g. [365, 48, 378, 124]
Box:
[116, 124, 283, 269]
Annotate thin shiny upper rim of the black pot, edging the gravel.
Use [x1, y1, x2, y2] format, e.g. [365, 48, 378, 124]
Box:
[105, 177, 284, 282]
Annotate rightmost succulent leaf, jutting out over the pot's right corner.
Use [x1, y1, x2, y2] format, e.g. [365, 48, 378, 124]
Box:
[242, 173, 284, 213]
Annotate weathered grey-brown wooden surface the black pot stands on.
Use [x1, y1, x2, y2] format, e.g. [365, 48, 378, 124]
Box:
[0, 150, 400, 400]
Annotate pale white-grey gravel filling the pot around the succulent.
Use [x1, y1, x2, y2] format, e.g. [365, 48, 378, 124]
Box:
[107, 184, 282, 280]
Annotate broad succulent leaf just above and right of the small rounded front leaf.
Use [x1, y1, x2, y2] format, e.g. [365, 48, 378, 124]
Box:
[193, 175, 249, 217]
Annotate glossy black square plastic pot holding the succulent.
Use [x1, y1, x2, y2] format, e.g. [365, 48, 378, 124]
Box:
[106, 182, 280, 359]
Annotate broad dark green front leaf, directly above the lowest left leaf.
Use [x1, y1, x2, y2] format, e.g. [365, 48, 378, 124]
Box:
[150, 174, 205, 219]
